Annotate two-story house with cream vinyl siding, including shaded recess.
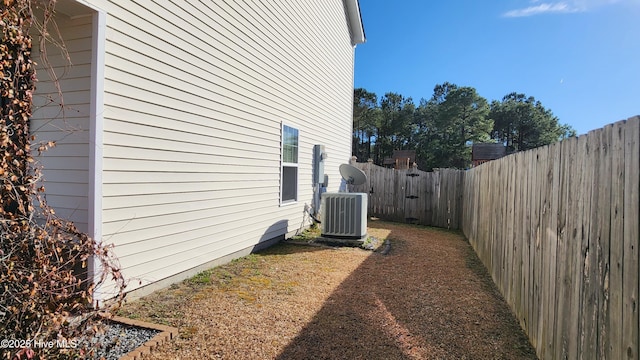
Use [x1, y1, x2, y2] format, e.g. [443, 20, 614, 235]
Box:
[31, 0, 365, 299]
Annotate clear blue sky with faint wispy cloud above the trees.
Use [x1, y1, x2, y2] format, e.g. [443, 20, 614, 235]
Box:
[355, 0, 640, 134]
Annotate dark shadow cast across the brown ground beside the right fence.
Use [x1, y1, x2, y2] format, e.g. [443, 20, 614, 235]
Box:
[276, 222, 536, 359]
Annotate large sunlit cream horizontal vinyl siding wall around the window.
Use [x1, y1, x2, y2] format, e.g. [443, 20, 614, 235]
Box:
[97, 0, 353, 289]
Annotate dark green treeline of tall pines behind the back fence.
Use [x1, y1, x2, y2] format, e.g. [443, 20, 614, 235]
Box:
[353, 82, 575, 171]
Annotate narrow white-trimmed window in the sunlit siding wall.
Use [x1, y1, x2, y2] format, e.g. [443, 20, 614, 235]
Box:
[280, 124, 298, 204]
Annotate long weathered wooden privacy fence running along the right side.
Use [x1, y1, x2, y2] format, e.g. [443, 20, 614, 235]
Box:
[462, 117, 640, 359]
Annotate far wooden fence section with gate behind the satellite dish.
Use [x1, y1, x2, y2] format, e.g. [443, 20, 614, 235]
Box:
[351, 162, 464, 229]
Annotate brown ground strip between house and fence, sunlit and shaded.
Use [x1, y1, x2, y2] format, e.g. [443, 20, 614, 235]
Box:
[116, 221, 535, 359]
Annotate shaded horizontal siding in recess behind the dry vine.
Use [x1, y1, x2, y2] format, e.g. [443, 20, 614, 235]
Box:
[31, 15, 92, 231]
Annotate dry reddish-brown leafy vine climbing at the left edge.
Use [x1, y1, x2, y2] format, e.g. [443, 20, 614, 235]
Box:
[0, 0, 125, 359]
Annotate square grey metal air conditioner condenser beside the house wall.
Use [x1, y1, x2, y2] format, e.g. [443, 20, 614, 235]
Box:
[320, 193, 367, 239]
